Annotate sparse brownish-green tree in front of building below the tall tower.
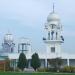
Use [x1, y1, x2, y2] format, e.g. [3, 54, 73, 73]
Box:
[48, 58, 63, 72]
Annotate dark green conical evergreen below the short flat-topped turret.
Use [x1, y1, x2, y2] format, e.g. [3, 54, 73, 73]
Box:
[17, 53, 27, 71]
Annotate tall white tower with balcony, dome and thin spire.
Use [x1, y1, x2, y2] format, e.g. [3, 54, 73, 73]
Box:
[43, 4, 64, 55]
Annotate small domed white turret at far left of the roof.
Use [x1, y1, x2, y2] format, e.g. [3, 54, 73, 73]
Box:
[2, 33, 15, 53]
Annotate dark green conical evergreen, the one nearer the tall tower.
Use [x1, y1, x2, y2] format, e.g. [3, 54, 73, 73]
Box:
[31, 53, 41, 71]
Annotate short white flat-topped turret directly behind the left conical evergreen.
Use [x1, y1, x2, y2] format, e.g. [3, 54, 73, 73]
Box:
[18, 37, 31, 55]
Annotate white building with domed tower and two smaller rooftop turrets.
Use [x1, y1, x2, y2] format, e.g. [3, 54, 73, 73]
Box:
[0, 5, 75, 68]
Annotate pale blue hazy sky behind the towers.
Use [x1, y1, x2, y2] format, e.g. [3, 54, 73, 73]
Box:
[0, 0, 75, 53]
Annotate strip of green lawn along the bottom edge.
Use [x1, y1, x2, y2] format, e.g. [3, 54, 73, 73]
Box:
[0, 72, 75, 75]
